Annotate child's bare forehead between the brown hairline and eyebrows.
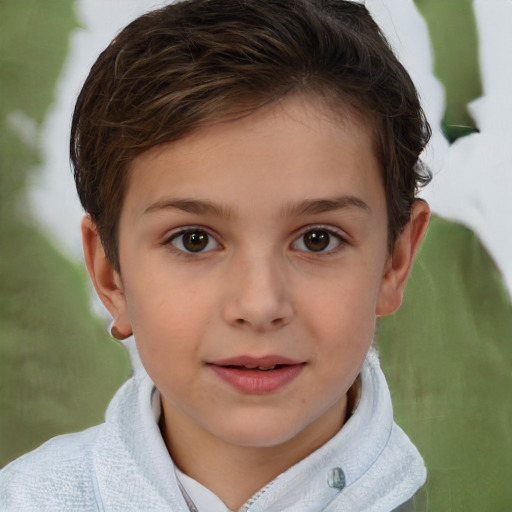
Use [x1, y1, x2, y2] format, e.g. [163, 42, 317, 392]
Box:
[121, 96, 382, 222]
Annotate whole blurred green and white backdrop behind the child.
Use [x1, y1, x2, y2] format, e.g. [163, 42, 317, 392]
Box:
[0, 0, 512, 512]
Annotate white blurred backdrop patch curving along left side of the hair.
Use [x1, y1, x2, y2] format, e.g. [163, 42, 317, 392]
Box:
[27, 0, 170, 260]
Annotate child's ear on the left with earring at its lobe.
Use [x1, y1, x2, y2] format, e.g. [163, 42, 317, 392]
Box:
[82, 216, 132, 339]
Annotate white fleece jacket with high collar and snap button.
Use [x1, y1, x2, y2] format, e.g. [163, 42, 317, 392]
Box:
[0, 349, 426, 512]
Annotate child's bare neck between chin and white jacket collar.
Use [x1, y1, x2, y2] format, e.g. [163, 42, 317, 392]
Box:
[160, 397, 356, 510]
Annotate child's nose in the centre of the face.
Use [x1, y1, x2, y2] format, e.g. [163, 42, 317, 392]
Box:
[223, 255, 294, 332]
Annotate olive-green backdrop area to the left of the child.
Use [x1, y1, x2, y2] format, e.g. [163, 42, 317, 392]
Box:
[0, 0, 129, 466]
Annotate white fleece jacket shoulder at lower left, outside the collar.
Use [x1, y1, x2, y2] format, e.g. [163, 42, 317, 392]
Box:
[0, 425, 102, 512]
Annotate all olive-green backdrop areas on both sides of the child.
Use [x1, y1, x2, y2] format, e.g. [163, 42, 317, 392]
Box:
[0, 0, 512, 512]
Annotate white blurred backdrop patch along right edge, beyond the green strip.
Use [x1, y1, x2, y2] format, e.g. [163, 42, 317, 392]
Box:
[418, 0, 512, 295]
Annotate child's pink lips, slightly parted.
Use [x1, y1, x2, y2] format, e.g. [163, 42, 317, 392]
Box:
[208, 355, 306, 395]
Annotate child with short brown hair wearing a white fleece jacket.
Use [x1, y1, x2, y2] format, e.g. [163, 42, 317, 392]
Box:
[0, 0, 430, 512]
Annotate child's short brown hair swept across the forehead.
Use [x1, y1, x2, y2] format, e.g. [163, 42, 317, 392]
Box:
[70, 0, 431, 270]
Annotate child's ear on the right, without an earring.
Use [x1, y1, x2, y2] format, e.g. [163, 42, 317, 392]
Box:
[376, 199, 430, 316]
